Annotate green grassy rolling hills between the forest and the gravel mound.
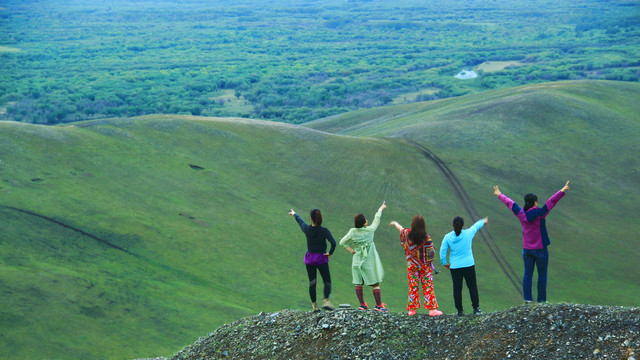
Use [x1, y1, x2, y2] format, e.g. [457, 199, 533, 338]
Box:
[0, 82, 640, 359]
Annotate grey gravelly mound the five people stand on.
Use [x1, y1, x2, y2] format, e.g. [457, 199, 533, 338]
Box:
[154, 304, 640, 360]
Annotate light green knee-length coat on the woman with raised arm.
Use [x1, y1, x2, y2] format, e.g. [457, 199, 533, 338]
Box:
[340, 211, 384, 285]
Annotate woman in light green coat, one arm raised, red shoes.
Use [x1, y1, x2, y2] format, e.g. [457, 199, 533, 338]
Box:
[340, 202, 389, 312]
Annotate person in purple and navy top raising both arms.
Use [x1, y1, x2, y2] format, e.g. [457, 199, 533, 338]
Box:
[493, 181, 569, 303]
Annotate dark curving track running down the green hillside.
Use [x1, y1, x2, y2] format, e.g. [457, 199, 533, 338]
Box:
[406, 139, 523, 296]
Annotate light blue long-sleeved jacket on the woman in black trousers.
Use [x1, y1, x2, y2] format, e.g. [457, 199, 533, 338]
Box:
[440, 219, 484, 269]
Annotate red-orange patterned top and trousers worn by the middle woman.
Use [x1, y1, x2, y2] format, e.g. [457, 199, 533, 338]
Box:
[400, 228, 438, 310]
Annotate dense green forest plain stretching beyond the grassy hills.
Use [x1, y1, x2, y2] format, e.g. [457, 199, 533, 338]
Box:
[0, 0, 640, 124]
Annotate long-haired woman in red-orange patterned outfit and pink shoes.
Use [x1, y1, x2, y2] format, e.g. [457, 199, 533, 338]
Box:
[389, 215, 442, 316]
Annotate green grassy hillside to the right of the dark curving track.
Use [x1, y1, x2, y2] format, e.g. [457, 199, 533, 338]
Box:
[308, 81, 640, 305]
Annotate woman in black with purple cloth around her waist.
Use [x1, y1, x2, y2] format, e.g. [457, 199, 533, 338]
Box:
[289, 209, 336, 311]
